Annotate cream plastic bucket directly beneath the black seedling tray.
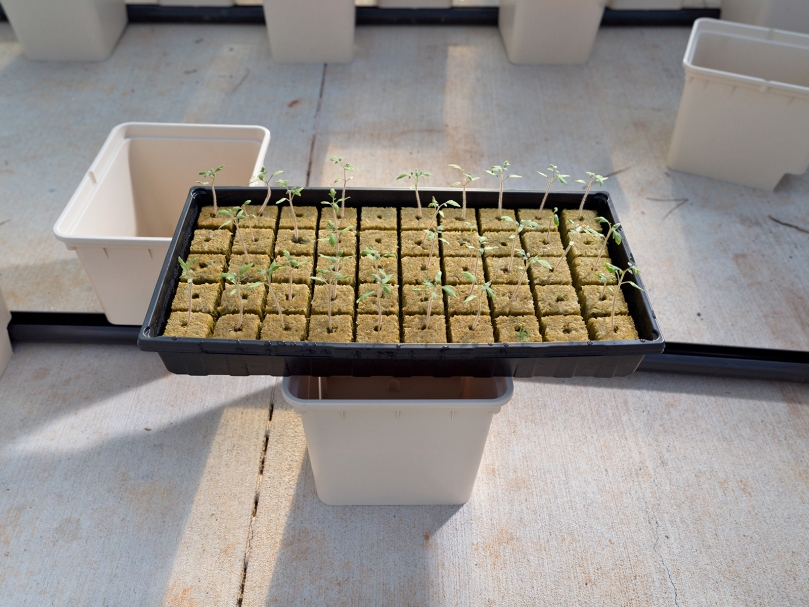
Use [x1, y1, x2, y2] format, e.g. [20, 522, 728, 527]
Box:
[283, 376, 514, 506]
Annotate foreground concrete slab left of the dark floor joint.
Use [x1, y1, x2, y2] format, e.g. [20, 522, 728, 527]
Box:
[0, 345, 275, 607]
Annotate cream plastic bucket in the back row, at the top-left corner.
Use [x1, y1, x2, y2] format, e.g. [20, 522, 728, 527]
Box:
[2, 0, 127, 61]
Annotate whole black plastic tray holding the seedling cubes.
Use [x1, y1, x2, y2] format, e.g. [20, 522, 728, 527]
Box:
[138, 187, 664, 377]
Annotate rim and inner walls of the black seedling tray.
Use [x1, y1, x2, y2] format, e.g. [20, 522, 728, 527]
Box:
[138, 186, 665, 360]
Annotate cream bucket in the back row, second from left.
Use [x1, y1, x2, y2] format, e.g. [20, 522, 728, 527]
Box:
[264, 0, 356, 63]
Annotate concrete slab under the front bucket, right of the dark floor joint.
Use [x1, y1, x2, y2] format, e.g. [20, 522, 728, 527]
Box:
[243, 374, 809, 607]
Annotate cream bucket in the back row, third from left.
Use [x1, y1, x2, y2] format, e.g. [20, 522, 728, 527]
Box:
[498, 0, 606, 65]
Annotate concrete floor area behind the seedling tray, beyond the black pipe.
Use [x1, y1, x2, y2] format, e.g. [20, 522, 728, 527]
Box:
[0, 23, 809, 350]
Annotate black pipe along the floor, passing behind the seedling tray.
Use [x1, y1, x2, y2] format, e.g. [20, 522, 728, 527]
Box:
[8, 312, 809, 382]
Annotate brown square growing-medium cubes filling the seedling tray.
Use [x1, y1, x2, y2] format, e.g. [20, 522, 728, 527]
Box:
[164, 197, 638, 344]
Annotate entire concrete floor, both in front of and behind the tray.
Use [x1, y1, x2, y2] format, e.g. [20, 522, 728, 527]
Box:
[0, 23, 809, 607]
